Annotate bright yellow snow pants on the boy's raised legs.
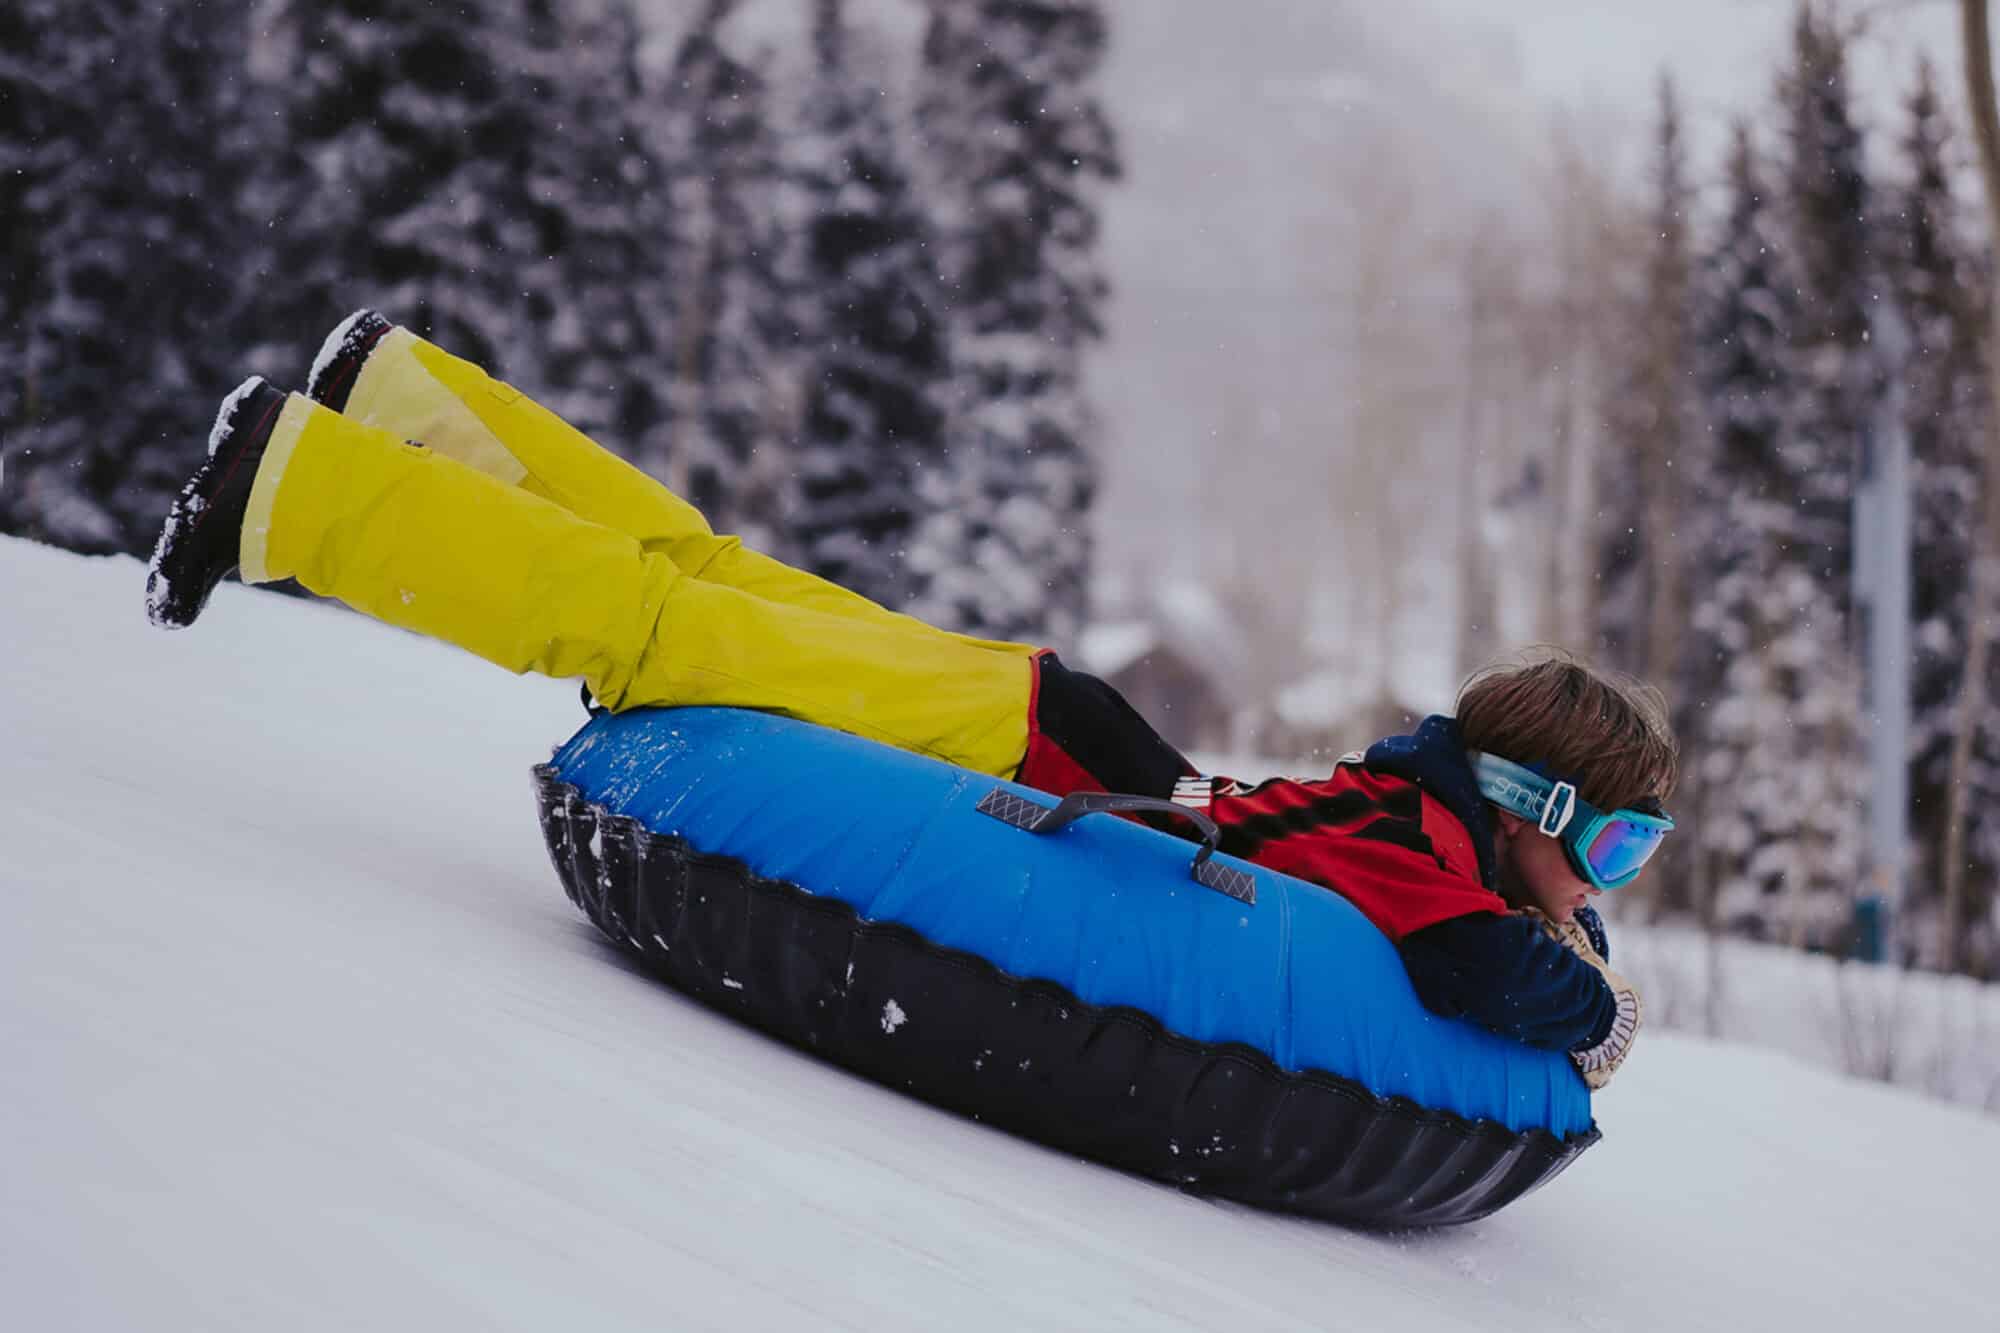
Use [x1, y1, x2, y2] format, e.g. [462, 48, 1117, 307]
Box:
[242, 328, 1036, 777]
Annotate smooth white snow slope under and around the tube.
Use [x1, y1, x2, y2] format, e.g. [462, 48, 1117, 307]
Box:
[0, 538, 2000, 1333]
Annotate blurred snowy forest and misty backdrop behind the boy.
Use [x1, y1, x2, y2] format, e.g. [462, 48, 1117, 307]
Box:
[11, 0, 2000, 1072]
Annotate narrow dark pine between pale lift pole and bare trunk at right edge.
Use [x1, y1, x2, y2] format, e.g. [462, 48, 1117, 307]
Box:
[1886, 62, 2000, 963]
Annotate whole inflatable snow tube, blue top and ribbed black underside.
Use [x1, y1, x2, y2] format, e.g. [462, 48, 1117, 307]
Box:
[536, 709, 1598, 1227]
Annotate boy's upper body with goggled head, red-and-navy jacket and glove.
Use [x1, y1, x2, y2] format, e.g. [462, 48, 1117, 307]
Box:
[1176, 656, 1676, 1087]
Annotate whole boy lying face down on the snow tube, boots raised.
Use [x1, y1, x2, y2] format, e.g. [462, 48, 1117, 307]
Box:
[146, 310, 1674, 1087]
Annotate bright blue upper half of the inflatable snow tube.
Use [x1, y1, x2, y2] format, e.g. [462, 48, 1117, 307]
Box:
[552, 709, 1592, 1135]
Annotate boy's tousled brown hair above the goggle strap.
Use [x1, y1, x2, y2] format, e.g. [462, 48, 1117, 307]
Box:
[1458, 650, 1680, 811]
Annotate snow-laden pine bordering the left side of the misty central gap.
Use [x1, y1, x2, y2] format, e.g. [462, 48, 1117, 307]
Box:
[912, 0, 1120, 640]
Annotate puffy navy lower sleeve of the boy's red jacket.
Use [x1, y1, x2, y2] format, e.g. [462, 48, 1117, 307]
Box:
[1398, 913, 1618, 1051]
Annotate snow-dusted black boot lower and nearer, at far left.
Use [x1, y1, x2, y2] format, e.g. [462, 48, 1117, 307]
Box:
[146, 374, 286, 628]
